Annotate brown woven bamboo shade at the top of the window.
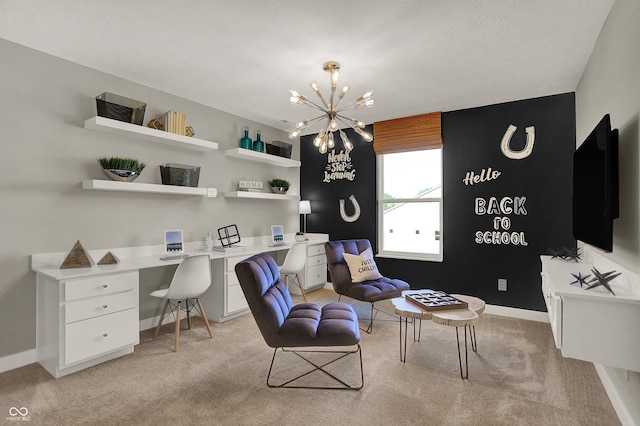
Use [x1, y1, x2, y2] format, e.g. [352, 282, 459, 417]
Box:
[373, 112, 442, 155]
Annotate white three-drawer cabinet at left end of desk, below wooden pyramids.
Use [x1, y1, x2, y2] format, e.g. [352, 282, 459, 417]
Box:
[37, 271, 140, 377]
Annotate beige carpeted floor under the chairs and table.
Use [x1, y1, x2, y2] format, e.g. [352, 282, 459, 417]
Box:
[0, 290, 620, 426]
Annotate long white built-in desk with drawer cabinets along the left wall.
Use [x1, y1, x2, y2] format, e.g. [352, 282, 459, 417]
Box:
[31, 234, 328, 377]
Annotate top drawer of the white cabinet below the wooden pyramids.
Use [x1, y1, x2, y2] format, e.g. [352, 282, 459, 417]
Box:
[64, 271, 138, 301]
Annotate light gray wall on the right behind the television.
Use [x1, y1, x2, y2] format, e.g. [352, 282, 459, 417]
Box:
[576, 0, 640, 419]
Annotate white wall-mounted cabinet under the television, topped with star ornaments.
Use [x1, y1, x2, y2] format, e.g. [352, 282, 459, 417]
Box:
[540, 256, 640, 371]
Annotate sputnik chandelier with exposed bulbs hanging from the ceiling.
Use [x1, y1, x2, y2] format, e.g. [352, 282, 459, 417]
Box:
[289, 61, 373, 154]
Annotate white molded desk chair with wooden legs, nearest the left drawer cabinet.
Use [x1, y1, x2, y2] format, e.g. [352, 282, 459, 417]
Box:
[151, 254, 213, 352]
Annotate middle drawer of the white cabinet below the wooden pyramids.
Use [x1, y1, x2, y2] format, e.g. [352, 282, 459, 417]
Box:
[64, 291, 138, 324]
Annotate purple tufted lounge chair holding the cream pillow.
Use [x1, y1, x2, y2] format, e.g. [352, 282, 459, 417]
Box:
[324, 239, 411, 333]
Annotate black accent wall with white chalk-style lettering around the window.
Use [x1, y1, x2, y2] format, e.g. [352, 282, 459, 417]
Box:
[300, 93, 576, 311]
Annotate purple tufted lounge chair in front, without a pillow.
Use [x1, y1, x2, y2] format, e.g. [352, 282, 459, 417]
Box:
[235, 253, 364, 389]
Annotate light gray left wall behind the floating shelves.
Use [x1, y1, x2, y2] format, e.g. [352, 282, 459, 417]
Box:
[0, 39, 300, 357]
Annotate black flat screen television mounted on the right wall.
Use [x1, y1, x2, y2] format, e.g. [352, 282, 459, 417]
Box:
[573, 114, 620, 252]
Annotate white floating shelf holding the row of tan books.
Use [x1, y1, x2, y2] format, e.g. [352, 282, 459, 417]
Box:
[84, 116, 218, 152]
